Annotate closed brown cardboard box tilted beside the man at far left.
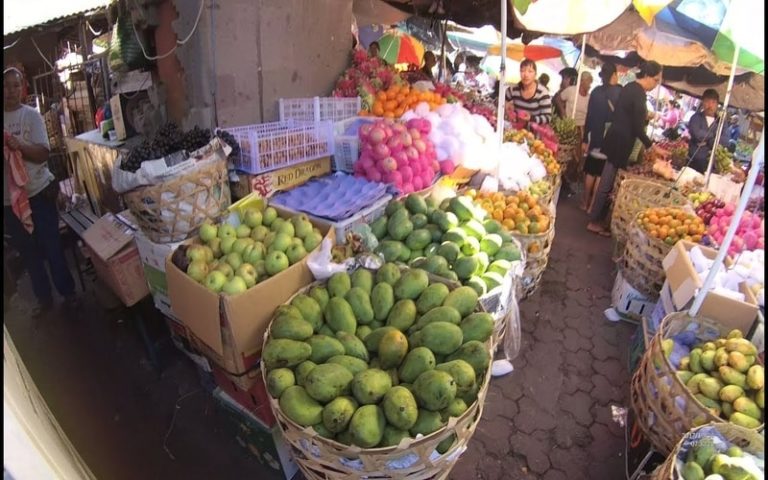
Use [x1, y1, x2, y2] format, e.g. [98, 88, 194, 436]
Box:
[83, 213, 149, 307]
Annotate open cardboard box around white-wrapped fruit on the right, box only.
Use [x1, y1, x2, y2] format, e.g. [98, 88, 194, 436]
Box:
[662, 241, 758, 335]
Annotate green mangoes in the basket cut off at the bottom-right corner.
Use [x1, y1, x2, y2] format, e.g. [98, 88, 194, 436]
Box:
[678, 437, 764, 480]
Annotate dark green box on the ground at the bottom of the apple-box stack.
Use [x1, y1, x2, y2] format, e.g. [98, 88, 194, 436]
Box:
[213, 388, 299, 480]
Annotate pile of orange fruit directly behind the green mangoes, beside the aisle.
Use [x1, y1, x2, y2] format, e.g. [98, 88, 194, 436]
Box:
[466, 189, 552, 235]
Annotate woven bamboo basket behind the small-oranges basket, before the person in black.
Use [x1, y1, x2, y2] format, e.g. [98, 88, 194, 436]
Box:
[611, 178, 688, 258]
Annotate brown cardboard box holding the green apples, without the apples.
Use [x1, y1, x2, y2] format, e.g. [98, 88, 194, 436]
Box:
[165, 207, 334, 375]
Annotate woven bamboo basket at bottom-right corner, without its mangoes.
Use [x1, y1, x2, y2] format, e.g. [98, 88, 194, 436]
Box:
[651, 423, 765, 480]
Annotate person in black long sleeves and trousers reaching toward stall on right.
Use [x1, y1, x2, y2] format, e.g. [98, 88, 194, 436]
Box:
[587, 61, 663, 237]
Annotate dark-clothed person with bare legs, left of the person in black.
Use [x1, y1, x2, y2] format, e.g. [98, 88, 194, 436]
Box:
[581, 62, 621, 211]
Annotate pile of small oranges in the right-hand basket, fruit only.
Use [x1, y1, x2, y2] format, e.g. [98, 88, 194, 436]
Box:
[637, 207, 706, 245]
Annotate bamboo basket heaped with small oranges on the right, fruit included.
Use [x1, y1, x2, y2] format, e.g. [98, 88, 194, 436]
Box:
[619, 208, 706, 299]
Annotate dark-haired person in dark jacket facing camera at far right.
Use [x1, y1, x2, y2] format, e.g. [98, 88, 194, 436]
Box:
[688, 88, 728, 173]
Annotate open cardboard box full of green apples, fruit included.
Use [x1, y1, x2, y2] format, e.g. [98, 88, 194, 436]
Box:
[166, 196, 334, 375]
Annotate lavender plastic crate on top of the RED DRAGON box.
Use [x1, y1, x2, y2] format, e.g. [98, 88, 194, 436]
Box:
[220, 120, 334, 174]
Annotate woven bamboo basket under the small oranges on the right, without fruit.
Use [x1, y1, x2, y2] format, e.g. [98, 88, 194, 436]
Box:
[619, 221, 672, 300]
